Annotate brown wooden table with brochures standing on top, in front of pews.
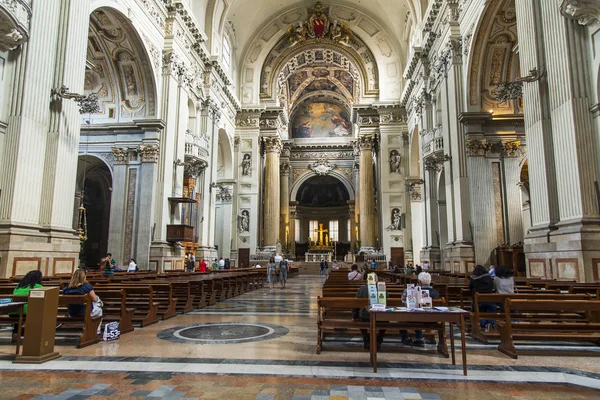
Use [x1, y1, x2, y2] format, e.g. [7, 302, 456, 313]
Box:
[369, 310, 467, 375]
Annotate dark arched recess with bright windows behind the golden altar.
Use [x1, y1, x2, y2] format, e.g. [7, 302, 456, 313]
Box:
[292, 175, 353, 258]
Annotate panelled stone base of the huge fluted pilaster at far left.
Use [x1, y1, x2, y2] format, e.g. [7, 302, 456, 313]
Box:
[0, 225, 80, 278]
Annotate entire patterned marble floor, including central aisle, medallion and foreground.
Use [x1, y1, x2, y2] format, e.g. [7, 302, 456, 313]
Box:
[0, 276, 600, 400]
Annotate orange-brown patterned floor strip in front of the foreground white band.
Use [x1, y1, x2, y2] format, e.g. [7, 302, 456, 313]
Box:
[0, 372, 600, 400]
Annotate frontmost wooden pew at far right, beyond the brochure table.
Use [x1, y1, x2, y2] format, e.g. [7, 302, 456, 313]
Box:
[497, 298, 600, 359]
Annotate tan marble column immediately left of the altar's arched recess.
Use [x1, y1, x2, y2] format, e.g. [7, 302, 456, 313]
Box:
[263, 136, 282, 250]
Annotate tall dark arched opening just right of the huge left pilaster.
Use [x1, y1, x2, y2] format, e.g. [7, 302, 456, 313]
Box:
[74, 156, 112, 265]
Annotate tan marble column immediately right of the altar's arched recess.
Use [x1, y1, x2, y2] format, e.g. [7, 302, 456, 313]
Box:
[358, 135, 377, 251]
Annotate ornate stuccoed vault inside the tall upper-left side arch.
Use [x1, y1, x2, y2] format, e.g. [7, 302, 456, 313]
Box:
[84, 2, 157, 123]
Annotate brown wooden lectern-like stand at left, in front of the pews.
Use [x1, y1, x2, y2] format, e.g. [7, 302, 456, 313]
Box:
[14, 287, 60, 364]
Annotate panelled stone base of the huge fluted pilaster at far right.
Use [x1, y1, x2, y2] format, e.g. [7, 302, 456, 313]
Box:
[524, 224, 600, 282]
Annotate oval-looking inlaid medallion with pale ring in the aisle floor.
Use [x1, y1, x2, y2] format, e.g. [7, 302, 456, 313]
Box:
[157, 322, 289, 344]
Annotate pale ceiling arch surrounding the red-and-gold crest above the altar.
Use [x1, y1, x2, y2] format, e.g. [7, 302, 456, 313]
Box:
[232, 0, 414, 106]
